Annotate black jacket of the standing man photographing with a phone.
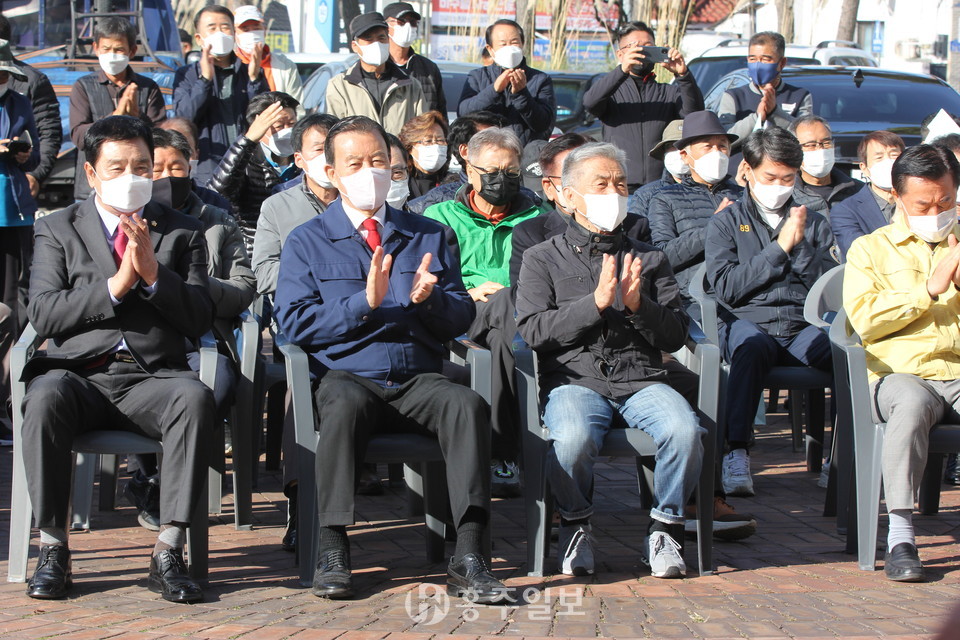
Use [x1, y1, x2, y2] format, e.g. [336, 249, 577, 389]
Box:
[583, 67, 703, 185]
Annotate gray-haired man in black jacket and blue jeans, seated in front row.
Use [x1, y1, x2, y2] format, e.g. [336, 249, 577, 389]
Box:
[517, 143, 703, 578]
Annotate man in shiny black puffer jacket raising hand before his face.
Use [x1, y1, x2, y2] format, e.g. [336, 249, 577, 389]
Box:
[207, 91, 300, 254]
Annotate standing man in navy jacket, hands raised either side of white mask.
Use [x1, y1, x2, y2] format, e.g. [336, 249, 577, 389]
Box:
[173, 4, 270, 185]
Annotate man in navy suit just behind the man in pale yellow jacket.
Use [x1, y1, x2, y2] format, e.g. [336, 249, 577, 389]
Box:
[830, 131, 906, 260]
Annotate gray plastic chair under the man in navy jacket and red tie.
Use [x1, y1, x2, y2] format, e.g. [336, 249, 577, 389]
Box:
[274, 332, 490, 586]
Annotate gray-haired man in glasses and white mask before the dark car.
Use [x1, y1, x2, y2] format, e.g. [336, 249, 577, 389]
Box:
[787, 115, 863, 214]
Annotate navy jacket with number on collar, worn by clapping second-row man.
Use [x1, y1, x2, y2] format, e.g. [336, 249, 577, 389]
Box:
[705, 189, 837, 337]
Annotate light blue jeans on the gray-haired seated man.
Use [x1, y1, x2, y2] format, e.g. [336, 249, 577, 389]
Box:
[543, 384, 705, 524]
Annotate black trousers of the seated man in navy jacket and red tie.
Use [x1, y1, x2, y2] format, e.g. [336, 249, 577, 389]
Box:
[314, 371, 490, 527]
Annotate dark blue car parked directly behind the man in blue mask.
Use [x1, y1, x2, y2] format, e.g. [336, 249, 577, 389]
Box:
[704, 66, 960, 177]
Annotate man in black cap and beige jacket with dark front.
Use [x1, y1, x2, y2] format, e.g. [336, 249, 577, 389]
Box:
[326, 12, 427, 135]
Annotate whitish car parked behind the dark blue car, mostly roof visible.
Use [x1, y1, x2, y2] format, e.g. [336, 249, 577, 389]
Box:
[687, 39, 877, 95]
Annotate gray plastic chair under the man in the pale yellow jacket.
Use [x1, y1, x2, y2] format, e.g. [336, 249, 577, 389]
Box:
[830, 309, 960, 571]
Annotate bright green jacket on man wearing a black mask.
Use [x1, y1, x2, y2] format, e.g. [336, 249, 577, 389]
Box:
[423, 183, 540, 289]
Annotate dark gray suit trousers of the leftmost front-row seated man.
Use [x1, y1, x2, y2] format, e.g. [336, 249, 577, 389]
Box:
[22, 362, 214, 528]
